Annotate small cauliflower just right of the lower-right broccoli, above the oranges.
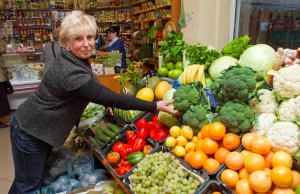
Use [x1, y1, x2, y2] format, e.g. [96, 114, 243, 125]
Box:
[252, 113, 277, 136]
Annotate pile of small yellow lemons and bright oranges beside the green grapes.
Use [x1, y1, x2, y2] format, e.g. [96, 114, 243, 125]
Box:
[166, 122, 241, 173]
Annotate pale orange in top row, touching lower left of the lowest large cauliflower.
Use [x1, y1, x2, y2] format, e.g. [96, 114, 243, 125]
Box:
[250, 136, 272, 154]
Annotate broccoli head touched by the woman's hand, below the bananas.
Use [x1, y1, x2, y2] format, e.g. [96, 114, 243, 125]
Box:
[173, 83, 201, 112]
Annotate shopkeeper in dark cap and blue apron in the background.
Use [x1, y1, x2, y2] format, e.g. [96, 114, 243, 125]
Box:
[106, 26, 127, 68]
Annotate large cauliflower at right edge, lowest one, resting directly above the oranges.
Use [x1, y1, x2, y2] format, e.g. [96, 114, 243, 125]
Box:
[267, 122, 300, 156]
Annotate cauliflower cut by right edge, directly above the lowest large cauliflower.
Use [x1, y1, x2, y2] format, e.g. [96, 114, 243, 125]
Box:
[277, 98, 300, 121]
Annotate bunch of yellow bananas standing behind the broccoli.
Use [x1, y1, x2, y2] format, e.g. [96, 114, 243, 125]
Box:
[182, 65, 206, 87]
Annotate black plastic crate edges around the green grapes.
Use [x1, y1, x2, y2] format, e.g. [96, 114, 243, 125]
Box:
[123, 146, 210, 194]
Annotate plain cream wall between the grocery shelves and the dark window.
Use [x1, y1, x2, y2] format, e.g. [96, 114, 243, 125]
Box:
[182, 0, 233, 50]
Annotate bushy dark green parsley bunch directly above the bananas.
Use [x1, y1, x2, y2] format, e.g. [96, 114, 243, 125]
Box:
[186, 45, 221, 69]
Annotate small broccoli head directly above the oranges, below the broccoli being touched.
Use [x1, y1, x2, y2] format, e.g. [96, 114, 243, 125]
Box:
[183, 105, 209, 134]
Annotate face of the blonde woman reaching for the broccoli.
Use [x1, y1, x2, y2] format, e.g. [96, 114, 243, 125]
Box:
[67, 32, 95, 59]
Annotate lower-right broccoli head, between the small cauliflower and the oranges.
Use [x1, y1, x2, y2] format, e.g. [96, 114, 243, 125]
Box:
[214, 101, 255, 134]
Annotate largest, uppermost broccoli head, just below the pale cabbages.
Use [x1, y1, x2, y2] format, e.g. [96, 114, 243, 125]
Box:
[212, 67, 257, 102]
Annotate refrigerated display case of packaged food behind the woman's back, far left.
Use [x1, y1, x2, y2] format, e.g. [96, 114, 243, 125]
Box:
[2, 53, 44, 110]
